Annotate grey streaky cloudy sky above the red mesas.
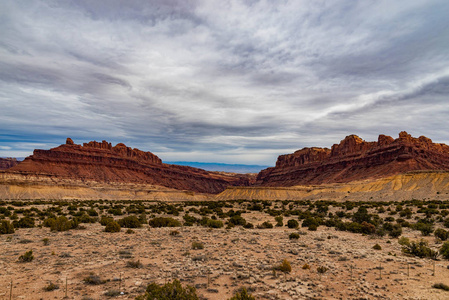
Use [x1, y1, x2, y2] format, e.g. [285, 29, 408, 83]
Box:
[0, 0, 449, 165]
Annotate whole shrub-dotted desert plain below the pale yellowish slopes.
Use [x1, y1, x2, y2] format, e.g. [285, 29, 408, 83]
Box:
[0, 200, 449, 300]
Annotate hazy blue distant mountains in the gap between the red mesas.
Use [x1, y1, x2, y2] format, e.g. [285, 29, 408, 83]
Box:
[165, 161, 269, 174]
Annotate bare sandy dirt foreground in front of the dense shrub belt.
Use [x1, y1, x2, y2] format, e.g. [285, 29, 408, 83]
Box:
[0, 219, 449, 299]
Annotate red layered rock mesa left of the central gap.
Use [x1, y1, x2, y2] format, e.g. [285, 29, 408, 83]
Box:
[7, 138, 251, 193]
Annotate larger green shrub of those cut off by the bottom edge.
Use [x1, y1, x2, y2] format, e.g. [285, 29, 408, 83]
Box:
[136, 279, 199, 300]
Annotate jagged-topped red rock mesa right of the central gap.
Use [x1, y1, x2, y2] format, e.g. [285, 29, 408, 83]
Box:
[257, 132, 449, 186]
